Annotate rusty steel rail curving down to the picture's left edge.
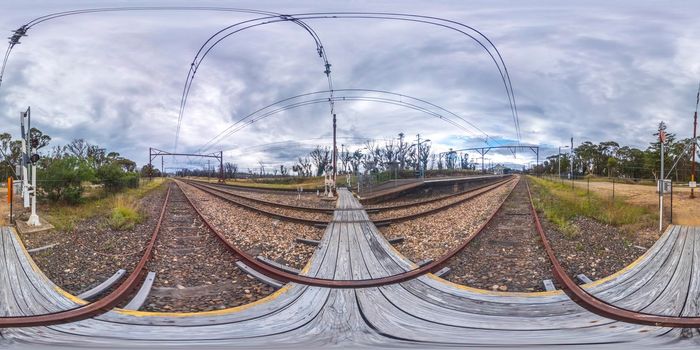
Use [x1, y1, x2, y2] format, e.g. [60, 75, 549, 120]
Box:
[0, 189, 170, 328]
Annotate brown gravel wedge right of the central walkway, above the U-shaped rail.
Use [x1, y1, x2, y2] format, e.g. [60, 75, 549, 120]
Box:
[380, 182, 515, 261]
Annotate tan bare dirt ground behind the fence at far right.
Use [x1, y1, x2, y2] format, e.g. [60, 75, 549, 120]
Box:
[574, 181, 700, 225]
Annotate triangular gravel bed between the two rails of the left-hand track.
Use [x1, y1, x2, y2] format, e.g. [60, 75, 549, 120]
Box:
[144, 183, 274, 312]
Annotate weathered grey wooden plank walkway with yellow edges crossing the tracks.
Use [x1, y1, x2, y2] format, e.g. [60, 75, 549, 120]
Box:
[0, 189, 700, 348]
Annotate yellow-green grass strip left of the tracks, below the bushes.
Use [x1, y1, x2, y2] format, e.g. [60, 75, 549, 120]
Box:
[42, 178, 165, 232]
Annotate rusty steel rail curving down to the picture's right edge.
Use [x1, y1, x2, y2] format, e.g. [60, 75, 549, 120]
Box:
[525, 182, 700, 328]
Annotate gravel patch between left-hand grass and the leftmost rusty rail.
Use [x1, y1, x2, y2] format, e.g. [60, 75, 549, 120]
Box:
[21, 188, 165, 294]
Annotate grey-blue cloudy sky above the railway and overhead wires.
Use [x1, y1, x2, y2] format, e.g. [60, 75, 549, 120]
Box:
[0, 0, 700, 170]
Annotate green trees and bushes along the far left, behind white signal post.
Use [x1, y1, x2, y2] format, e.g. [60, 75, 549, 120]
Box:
[0, 128, 140, 204]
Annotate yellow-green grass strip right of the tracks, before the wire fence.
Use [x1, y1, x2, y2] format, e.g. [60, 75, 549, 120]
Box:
[529, 177, 658, 238]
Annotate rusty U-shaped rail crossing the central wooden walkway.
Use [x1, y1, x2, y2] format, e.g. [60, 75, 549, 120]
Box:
[176, 176, 514, 289]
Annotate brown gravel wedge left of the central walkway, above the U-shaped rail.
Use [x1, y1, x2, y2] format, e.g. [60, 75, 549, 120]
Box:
[181, 184, 324, 269]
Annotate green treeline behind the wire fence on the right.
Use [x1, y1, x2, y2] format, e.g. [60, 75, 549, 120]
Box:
[538, 122, 697, 181]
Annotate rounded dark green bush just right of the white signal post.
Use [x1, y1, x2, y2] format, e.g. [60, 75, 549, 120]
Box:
[37, 157, 94, 204]
